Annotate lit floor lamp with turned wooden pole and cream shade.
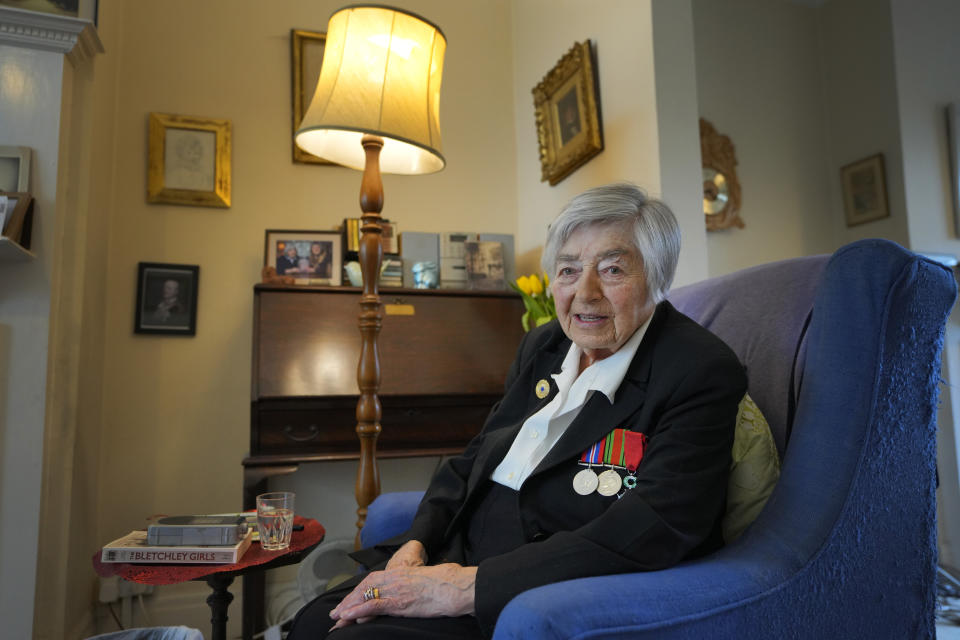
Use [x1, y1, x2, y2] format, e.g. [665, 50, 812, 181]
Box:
[296, 6, 447, 543]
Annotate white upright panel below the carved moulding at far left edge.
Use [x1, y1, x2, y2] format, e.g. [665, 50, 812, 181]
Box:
[0, 45, 64, 638]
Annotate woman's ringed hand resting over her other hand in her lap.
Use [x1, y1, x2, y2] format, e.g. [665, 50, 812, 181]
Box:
[330, 564, 477, 629]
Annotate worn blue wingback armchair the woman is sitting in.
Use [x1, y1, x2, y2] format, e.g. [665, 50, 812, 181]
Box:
[361, 240, 956, 640]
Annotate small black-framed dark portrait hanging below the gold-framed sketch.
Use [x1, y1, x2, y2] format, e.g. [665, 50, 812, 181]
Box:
[133, 262, 200, 336]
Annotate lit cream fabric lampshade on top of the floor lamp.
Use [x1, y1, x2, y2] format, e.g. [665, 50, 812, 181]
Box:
[296, 6, 447, 174]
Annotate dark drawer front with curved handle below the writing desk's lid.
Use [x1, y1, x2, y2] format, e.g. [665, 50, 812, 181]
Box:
[250, 396, 498, 455]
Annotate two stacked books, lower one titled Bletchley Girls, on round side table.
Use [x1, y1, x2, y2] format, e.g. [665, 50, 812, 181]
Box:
[100, 516, 254, 564]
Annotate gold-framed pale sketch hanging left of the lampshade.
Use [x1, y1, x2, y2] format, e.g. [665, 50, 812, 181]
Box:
[147, 113, 231, 208]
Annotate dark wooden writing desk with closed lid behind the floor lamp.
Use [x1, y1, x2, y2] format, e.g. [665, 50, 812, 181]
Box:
[243, 284, 524, 637]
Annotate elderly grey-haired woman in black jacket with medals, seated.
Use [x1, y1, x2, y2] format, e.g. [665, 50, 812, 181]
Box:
[289, 184, 746, 640]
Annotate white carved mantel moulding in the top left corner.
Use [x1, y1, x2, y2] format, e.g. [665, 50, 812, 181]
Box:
[0, 7, 103, 64]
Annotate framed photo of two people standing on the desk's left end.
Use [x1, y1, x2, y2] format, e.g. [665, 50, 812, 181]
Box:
[263, 229, 343, 287]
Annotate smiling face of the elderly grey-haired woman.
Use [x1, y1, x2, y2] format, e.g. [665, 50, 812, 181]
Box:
[551, 224, 656, 364]
